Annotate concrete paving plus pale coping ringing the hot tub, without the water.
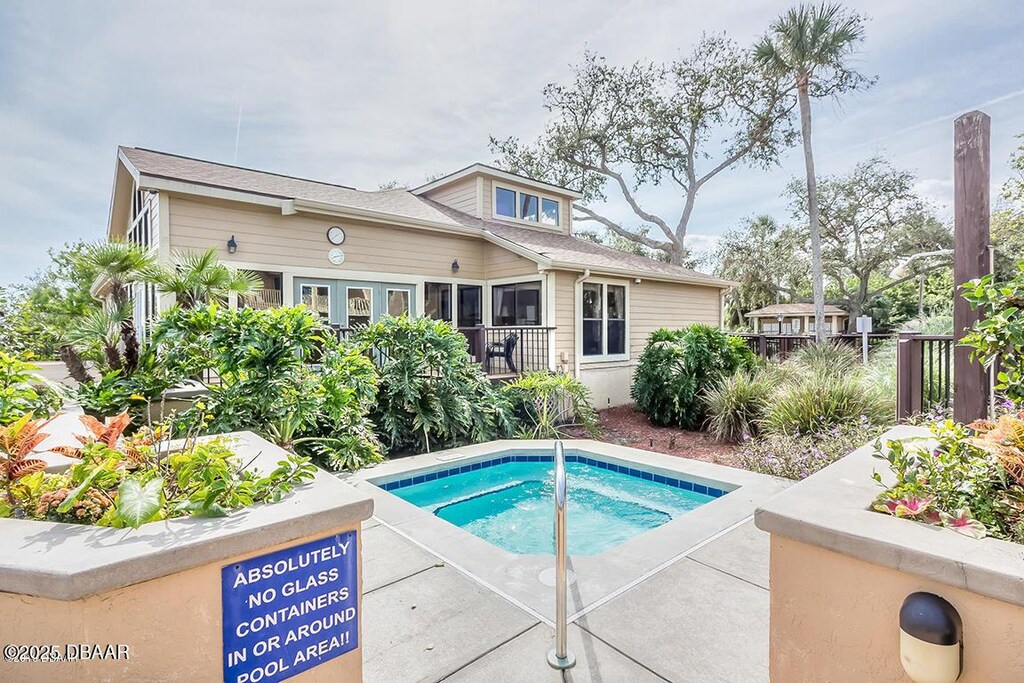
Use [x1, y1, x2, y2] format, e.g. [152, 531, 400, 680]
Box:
[346, 441, 790, 683]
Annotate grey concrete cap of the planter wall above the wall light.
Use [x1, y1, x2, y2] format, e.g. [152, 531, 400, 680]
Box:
[754, 426, 1024, 606]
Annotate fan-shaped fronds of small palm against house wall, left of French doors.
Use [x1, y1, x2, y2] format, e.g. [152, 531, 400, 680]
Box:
[144, 248, 262, 308]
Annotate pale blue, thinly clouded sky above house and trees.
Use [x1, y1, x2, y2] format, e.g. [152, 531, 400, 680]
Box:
[0, 0, 1024, 283]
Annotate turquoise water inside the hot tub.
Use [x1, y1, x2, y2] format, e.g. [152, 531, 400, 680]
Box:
[383, 456, 724, 555]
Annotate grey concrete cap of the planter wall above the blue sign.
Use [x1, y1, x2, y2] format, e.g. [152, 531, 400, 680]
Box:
[0, 432, 374, 600]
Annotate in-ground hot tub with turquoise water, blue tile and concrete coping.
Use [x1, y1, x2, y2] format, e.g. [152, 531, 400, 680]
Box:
[342, 439, 788, 622]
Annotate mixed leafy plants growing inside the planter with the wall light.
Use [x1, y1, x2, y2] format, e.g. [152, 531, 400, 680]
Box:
[874, 413, 1024, 543]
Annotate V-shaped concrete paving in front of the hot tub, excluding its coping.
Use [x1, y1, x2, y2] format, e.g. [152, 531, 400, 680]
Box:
[362, 520, 769, 683]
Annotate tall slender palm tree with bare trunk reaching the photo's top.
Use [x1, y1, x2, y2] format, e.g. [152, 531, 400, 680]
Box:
[754, 3, 869, 342]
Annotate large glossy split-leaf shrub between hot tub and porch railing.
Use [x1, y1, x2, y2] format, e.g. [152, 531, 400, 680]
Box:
[354, 316, 513, 453]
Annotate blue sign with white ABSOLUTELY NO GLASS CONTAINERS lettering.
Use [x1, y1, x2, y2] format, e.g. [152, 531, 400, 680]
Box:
[220, 531, 359, 683]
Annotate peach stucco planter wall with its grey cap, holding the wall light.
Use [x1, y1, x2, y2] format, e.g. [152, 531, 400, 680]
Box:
[756, 427, 1024, 683]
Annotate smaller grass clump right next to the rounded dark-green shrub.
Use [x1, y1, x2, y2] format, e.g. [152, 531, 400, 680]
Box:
[701, 370, 774, 441]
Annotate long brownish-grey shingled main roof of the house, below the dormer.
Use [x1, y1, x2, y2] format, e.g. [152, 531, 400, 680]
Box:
[120, 146, 730, 287]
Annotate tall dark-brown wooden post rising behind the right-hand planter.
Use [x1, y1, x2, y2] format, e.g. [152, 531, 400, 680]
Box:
[953, 112, 990, 423]
